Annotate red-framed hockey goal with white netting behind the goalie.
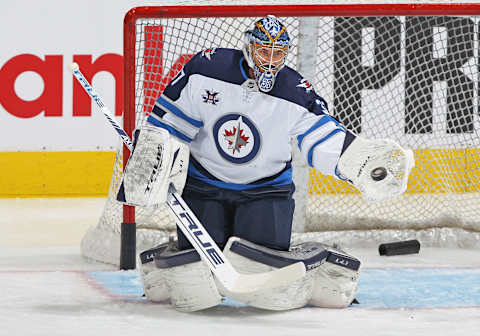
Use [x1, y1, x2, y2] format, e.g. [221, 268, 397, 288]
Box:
[82, 4, 480, 267]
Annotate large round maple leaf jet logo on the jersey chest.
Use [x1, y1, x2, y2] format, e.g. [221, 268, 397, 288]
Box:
[213, 113, 261, 164]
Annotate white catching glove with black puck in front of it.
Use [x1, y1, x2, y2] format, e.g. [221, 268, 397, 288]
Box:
[337, 137, 415, 202]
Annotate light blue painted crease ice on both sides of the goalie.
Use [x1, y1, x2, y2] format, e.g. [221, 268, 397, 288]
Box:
[85, 268, 480, 309]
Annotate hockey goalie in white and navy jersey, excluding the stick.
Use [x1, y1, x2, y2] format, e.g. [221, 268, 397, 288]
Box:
[118, 16, 414, 311]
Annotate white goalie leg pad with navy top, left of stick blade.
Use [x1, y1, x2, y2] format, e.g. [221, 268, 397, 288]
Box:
[141, 243, 222, 312]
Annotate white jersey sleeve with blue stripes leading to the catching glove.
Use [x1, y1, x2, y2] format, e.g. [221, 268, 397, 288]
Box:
[293, 90, 355, 179]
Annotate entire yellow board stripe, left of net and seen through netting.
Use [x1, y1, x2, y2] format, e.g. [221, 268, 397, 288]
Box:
[0, 148, 480, 198]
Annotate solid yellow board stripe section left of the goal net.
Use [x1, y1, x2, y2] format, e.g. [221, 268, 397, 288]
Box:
[0, 152, 115, 198]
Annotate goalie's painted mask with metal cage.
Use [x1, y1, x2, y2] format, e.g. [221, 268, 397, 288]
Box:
[243, 15, 290, 92]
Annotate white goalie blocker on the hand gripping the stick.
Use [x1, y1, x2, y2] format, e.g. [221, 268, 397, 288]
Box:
[123, 126, 190, 207]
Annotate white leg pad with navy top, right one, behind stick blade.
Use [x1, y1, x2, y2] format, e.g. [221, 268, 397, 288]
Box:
[221, 237, 360, 310]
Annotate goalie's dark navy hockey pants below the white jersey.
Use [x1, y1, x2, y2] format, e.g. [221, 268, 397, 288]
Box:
[177, 177, 295, 251]
